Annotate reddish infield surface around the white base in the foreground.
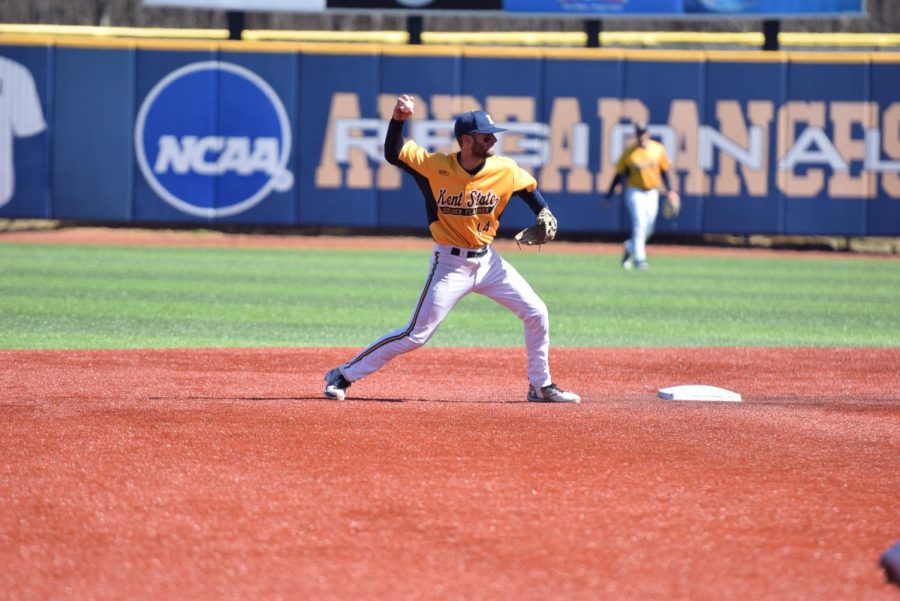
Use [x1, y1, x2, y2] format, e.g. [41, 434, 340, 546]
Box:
[0, 227, 900, 600]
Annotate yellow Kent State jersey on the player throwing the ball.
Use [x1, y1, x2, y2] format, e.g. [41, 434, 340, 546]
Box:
[399, 140, 537, 248]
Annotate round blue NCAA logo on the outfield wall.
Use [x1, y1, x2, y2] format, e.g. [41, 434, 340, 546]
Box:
[134, 61, 294, 217]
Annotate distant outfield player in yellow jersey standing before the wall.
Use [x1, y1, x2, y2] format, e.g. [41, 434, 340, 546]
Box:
[606, 123, 678, 269]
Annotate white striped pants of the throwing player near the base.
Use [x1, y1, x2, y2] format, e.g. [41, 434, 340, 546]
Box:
[341, 244, 552, 389]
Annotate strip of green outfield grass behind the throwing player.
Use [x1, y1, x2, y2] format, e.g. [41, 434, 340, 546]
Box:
[0, 244, 900, 349]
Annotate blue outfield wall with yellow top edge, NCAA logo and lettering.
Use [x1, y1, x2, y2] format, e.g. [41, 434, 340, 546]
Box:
[0, 35, 900, 236]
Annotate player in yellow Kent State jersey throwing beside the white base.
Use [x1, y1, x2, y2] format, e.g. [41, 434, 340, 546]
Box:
[325, 95, 581, 403]
